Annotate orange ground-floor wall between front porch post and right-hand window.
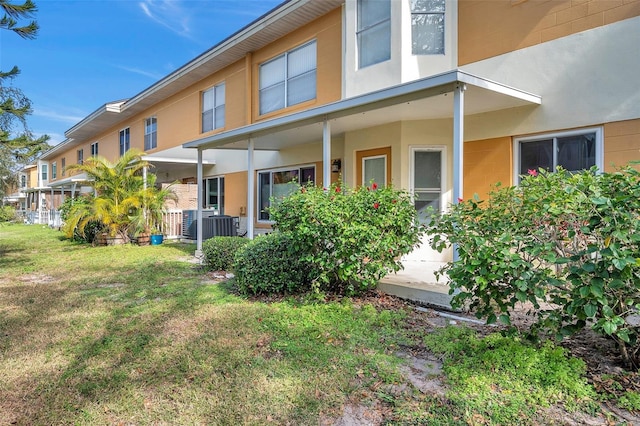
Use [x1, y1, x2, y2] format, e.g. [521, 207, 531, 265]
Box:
[463, 136, 513, 200]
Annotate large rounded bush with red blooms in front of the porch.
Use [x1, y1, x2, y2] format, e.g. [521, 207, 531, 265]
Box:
[269, 183, 423, 295]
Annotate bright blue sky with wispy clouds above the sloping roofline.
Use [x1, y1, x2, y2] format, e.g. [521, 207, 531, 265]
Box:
[0, 0, 283, 145]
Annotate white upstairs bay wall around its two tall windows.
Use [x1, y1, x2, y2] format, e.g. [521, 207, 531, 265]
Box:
[344, 0, 458, 98]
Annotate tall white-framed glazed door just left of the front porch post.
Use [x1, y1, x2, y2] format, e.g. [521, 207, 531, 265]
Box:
[411, 147, 444, 223]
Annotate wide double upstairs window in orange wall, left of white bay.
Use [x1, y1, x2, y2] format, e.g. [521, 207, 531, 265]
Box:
[255, 40, 317, 114]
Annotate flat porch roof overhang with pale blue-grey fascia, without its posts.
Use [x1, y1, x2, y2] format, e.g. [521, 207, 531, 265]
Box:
[182, 70, 542, 151]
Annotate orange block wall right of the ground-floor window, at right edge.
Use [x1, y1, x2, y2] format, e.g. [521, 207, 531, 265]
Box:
[604, 118, 640, 172]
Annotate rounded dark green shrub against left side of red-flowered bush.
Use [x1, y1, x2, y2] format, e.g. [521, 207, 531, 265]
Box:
[233, 232, 308, 295]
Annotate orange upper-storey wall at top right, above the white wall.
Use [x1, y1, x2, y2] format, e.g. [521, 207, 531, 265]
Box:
[458, 0, 640, 65]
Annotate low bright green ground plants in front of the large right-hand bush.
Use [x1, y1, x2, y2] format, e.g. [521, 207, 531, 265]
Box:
[424, 327, 595, 424]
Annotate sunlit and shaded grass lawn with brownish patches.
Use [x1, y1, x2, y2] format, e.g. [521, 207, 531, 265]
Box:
[0, 225, 636, 425]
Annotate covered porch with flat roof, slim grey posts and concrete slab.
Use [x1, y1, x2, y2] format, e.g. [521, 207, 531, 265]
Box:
[183, 70, 541, 306]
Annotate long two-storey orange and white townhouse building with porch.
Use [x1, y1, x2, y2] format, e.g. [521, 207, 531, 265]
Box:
[33, 0, 640, 306]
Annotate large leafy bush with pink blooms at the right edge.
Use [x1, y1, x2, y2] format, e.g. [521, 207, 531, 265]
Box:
[427, 167, 640, 367]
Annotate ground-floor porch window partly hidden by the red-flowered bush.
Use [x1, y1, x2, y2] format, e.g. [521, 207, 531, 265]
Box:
[258, 166, 316, 220]
